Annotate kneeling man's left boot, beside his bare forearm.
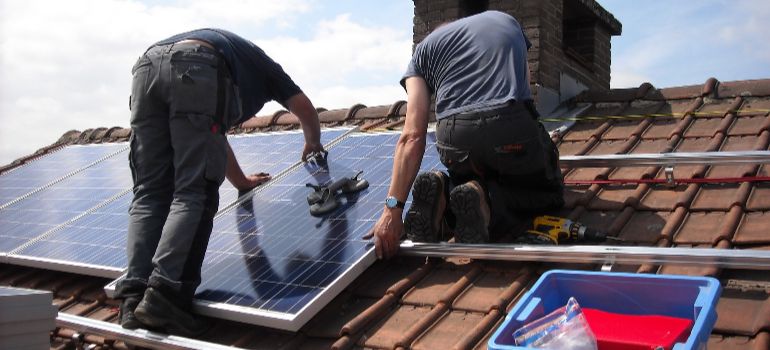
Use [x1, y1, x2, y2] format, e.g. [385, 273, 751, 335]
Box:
[404, 170, 448, 242]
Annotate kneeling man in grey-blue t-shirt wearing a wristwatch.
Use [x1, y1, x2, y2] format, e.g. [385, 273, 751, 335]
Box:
[370, 11, 564, 257]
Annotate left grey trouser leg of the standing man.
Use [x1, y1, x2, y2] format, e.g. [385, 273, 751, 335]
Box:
[116, 50, 174, 298]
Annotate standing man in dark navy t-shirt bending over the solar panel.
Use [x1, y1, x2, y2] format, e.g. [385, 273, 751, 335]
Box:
[116, 29, 324, 336]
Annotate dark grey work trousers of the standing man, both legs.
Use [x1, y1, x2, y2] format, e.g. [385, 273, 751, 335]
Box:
[116, 43, 237, 306]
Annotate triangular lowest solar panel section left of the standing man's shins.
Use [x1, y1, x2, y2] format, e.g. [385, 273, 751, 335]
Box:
[11, 193, 133, 278]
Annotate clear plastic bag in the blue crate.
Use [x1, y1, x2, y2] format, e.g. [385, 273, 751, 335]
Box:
[513, 298, 597, 350]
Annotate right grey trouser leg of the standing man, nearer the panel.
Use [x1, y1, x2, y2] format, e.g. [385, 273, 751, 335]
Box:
[144, 45, 227, 305]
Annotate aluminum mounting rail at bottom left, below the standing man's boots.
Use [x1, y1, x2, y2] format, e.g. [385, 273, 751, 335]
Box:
[56, 312, 239, 350]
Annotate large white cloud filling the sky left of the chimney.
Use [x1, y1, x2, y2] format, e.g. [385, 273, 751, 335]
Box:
[0, 0, 411, 164]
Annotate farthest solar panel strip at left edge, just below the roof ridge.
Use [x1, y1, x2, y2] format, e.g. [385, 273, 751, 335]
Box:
[0, 143, 127, 208]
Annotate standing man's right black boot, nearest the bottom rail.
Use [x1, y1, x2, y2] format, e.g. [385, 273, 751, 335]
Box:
[134, 287, 210, 337]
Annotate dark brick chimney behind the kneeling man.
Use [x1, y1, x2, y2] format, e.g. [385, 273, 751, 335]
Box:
[413, 0, 622, 113]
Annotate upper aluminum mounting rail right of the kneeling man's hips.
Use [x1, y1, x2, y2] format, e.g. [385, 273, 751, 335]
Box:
[559, 151, 770, 168]
